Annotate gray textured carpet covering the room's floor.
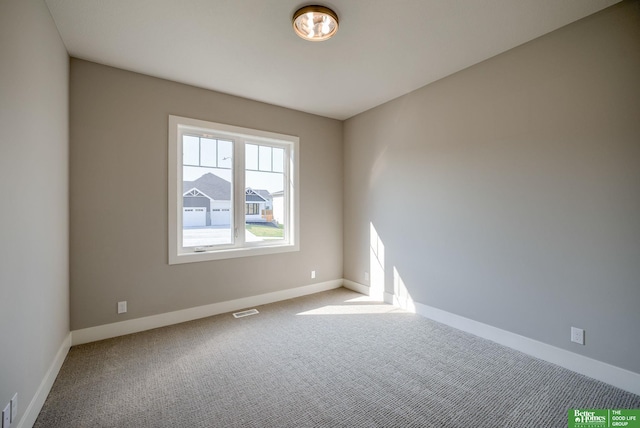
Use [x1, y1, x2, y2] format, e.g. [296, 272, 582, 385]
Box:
[35, 288, 640, 428]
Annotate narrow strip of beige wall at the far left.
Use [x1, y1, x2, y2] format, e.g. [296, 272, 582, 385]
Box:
[0, 0, 69, 427]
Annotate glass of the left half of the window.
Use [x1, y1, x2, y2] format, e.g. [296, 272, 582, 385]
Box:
[182, 137, 234, 248]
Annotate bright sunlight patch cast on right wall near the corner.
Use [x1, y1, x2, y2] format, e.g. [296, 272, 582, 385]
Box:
[369, 222, 416, 313]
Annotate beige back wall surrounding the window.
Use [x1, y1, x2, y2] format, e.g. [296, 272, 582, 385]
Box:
[70, 59, 342, 330]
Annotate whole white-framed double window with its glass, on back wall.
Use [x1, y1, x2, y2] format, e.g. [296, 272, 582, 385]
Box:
[169, 116, 299, 264]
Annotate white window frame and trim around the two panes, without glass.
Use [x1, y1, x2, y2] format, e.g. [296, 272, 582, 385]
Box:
[168, 115, 300, 265]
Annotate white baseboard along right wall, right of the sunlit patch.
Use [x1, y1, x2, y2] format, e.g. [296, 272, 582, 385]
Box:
[415, 302, 640, 395]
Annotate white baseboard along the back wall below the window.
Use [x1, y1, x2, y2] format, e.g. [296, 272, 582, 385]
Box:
[71, 279, 343, 345]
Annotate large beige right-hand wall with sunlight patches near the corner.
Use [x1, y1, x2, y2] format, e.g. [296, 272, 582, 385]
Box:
[344, 1, 640, 373]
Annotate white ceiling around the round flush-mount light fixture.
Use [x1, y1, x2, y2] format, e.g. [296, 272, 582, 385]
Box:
[46, 0, 619, 119]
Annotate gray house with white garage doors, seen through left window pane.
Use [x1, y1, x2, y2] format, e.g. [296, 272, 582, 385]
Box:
[182, 173, 231, 227]
